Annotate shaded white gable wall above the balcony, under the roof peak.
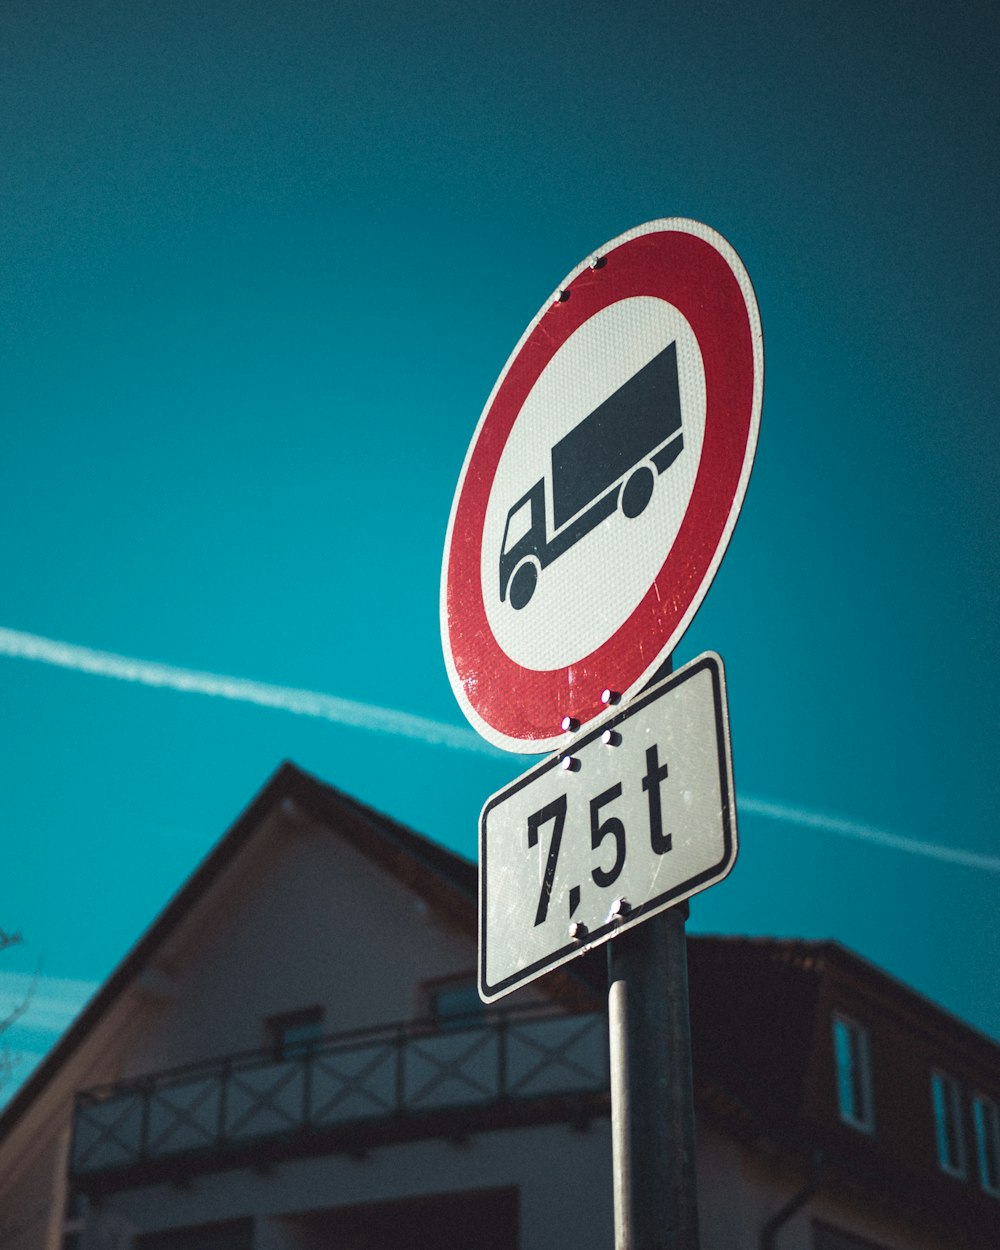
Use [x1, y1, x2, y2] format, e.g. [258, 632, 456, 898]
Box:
[120, 800, 485, 1075]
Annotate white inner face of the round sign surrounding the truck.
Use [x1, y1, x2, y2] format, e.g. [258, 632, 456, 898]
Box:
[480, 296, 705, 670]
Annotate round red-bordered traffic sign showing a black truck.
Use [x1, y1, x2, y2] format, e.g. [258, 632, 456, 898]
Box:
[441, 218, 764, 753]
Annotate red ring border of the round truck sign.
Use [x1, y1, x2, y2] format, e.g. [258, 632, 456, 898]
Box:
[441, 223, 763, 751]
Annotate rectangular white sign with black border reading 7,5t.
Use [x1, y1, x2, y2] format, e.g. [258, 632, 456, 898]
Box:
[479, 653, 736, 1003]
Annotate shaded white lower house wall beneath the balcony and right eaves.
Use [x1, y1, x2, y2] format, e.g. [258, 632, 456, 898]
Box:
[74, 1119, 961, 1250]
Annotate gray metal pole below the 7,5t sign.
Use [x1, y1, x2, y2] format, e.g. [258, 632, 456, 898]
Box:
[608, 904, 699, 1250]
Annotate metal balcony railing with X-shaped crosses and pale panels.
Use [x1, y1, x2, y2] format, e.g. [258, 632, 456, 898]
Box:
[70, 1010, 609, 1180]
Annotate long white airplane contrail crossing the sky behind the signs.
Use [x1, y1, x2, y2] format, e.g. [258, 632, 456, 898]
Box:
[0, 626, 1000, 873]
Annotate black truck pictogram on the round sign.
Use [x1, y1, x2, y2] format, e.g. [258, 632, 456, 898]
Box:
[500, 343, 684, 609]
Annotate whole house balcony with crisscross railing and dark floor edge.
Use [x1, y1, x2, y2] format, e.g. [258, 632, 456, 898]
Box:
[70, 1010, 609, 1191]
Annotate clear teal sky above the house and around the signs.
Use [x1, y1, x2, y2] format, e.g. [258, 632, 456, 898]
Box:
[0, 0, 1000, 1090]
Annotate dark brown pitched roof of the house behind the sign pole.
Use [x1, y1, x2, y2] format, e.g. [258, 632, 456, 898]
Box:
[0, 763, 996, 1180]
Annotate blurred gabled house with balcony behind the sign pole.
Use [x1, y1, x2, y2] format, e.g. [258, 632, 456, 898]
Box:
[0, 765, 1000, 1250]
